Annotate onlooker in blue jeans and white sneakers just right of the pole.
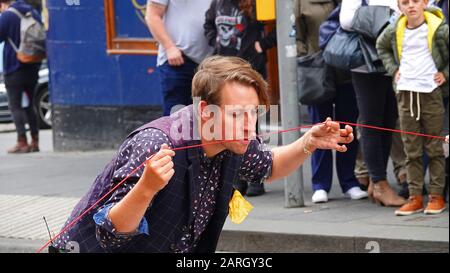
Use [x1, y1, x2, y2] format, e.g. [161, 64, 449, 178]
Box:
[295, 0, 367, 203]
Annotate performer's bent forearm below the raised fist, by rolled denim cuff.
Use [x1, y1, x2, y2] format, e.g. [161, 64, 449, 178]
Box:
[109, 177, 156, 233]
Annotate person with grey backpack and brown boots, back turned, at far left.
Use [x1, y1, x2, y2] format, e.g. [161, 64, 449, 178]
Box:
[0, 0, 41, 154]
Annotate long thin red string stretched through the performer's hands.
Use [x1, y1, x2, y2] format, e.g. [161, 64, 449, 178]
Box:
[36, 121, 445, 253]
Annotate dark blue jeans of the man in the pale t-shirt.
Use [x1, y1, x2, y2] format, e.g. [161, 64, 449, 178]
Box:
[159, 57, 198, 116]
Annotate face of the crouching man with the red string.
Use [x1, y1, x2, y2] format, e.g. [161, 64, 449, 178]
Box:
[200, 83, 259, 154]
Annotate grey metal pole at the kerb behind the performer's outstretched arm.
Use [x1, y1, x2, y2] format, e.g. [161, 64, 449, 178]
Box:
[276, 0, 304, 208]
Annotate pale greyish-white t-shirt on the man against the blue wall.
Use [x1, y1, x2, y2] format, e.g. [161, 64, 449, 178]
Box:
[148, 0, 213, 66]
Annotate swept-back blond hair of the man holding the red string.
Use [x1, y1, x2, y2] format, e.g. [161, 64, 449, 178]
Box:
[192, 56, 270, 108]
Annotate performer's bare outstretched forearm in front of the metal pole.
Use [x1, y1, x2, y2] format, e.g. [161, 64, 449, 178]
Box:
[267, 133, 314, 182]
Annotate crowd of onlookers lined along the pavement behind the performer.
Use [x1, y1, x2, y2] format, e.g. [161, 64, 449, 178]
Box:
[147, 0, 448, 215]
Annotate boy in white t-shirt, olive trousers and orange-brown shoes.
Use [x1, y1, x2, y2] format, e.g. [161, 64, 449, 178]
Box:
[377, 0, 449, 215]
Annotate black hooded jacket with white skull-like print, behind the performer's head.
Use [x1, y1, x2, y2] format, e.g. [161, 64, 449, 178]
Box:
[204, 0, 276, 77]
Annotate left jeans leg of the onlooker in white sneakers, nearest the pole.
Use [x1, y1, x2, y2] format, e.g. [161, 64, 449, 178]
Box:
[308, 102, 333, 193]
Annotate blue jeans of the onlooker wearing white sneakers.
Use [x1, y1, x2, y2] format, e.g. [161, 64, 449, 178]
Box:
[308, 83, 359, 192]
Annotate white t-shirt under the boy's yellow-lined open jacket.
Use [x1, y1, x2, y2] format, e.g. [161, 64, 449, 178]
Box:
[397, 23, 438, 93]
